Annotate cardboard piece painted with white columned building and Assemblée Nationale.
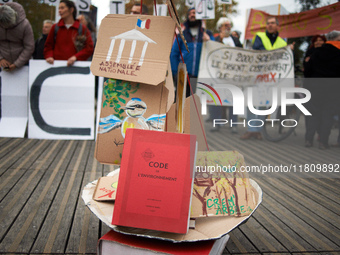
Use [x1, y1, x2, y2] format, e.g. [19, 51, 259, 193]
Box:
[91, 14, 175, 85]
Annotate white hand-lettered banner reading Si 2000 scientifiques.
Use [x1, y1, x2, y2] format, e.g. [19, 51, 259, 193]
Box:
[198, 41, 294, 106]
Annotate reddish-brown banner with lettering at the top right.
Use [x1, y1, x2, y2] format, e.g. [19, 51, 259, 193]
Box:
[245, 2, 340, 39]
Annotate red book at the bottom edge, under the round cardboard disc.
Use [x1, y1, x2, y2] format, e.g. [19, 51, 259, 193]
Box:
[97, 230, 229, 255]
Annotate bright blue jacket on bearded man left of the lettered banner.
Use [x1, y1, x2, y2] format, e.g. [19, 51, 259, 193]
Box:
[170, 22, 214, 77]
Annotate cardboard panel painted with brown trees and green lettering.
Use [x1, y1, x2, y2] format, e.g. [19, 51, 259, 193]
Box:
[190, 151, 255, 218]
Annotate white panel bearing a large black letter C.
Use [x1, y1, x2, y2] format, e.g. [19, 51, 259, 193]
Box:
[28, 60, 94, 140]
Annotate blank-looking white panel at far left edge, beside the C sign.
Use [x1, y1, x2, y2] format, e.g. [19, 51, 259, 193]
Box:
[0, 66, 28, 138]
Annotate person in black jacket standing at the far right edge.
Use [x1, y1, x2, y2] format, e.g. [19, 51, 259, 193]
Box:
[305, 31, 340, 150]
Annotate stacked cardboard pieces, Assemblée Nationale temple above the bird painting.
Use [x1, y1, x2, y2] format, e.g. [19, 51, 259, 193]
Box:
[91, 15, 175, 164]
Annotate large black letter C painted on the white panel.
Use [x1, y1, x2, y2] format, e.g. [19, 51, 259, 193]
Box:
[30, 66, 91, 135]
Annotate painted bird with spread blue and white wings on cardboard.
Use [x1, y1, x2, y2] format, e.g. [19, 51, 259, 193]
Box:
[98, 97, 165, 138]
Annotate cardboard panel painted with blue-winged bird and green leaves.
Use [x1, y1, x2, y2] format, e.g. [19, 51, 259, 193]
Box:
[95, 79, 169, 164]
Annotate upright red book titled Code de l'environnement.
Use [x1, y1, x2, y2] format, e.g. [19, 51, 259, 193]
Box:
[112, 128, 196, 234]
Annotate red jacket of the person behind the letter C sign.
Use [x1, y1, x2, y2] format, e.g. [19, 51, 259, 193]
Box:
[44, 19, 93, 60]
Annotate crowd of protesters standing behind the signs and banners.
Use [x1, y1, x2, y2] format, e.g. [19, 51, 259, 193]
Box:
[0, 0, 340, 149]
